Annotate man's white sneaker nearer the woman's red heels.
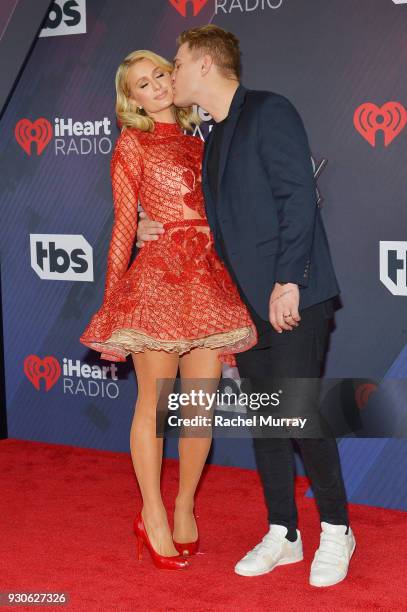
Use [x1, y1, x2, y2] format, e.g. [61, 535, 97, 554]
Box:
[235, 525, 304, 576]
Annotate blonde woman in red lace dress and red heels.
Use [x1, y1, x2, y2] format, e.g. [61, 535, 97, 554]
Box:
[80, 50, 257, 569]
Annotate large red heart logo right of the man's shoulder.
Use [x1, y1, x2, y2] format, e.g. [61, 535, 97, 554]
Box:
[353, 102, 407, 147]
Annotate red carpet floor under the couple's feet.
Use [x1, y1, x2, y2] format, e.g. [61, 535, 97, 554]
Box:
[0, 440, 407, 612]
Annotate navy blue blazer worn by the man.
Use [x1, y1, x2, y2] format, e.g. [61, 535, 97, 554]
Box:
[202, 84, 340, 320]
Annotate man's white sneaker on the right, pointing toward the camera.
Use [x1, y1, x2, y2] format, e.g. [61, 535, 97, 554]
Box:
[309, 522, 356, 586]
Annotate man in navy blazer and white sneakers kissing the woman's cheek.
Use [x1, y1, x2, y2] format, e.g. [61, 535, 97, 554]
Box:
[137, 25, 355, 586]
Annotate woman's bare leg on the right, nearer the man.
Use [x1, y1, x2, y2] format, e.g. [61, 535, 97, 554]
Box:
[173, 348, 222, 542]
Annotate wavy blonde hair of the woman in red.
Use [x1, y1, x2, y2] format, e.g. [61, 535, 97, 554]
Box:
[115, 49, 201, 132]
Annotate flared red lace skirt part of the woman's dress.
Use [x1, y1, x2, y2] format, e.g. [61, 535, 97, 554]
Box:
[80, 219, 257, 365]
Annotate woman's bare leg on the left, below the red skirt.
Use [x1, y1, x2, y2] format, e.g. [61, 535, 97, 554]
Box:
[130, 351, 179, 556]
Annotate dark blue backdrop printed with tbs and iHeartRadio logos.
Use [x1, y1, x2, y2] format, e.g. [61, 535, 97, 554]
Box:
[0, 0, 407, 509]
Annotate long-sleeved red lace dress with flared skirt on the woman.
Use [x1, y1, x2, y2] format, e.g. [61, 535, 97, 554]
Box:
[80, 122, 257, 365]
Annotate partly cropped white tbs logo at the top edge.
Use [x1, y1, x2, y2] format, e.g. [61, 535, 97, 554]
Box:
[39, 0, 86, 37]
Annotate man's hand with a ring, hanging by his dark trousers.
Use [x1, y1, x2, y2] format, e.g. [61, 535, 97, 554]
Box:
[269, 283, 301, 334]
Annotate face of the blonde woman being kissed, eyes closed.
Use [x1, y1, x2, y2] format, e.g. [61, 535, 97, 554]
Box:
[127, 59, 173, 114]
